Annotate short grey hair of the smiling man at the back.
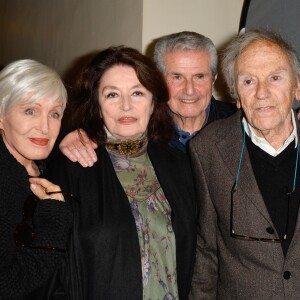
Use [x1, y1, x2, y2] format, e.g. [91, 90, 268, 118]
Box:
[153, 31, 218, 79]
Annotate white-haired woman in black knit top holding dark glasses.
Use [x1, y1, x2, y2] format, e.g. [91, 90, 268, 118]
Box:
[0, 59, 72, 300]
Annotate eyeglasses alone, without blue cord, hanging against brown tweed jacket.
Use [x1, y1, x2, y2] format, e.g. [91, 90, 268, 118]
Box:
[230, 182, 294, 243]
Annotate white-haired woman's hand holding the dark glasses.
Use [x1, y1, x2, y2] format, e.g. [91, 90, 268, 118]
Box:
[29, 178, 64, 201]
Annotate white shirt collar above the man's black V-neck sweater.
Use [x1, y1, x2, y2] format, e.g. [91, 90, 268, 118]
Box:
[242, 111, 298, 157]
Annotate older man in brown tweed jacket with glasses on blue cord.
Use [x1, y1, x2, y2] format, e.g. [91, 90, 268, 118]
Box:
[190, 30, 300, 300]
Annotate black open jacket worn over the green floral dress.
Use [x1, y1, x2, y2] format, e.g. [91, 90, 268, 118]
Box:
[46, 143, 197, 300]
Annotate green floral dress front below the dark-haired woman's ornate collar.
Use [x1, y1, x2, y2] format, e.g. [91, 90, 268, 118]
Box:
[109, 152, 178, 300]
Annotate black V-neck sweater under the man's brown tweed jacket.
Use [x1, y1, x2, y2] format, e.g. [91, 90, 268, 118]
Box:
[246, 136, 300, 255]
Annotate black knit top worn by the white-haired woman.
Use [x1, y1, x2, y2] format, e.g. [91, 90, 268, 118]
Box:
[0, 138, 72, 300]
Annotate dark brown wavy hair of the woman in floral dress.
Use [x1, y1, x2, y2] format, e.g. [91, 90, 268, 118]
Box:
[71, 46, 174, 144]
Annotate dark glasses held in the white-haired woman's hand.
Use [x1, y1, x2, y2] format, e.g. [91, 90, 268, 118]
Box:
[15, 191, 78, 252]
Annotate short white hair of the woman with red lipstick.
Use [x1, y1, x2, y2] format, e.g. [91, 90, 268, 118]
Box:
[0, 59, 67, 117]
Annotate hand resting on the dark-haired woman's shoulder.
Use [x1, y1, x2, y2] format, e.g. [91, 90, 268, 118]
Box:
[59, 129, 98, 167]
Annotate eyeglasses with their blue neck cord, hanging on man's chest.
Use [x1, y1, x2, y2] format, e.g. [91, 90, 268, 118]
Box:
[230, 130, 300, 243]
